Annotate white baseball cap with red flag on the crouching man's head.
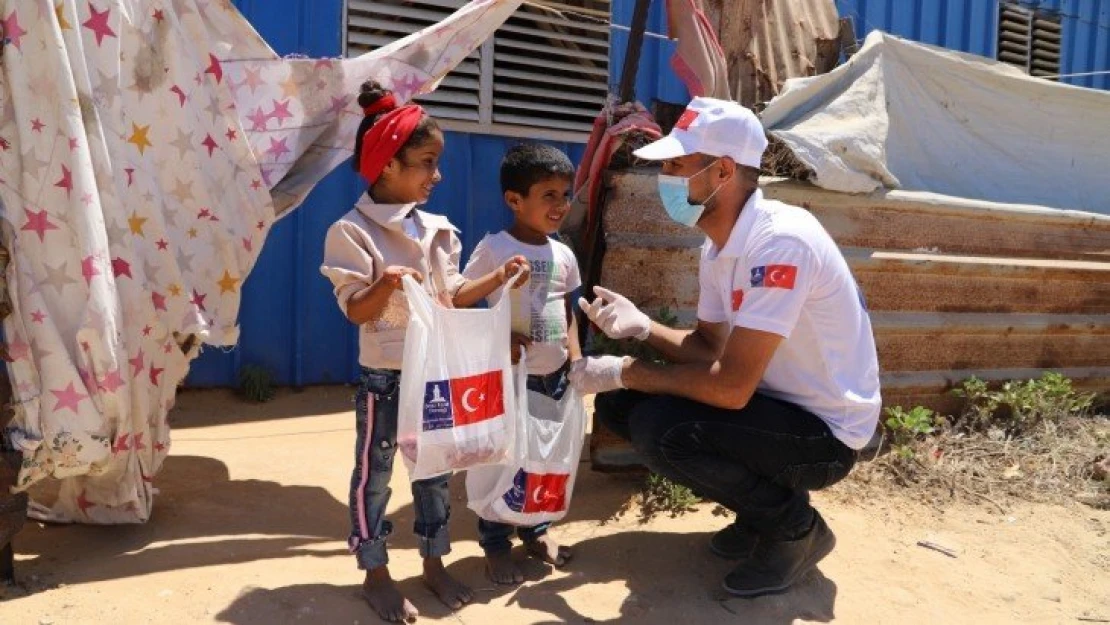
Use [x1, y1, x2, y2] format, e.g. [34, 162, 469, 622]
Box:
[633, 98, 767, 169]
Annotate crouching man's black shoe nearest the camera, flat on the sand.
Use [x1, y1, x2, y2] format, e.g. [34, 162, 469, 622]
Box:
[723, 511, 836, 597]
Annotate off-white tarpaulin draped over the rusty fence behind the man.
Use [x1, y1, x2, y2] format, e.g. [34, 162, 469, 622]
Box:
[763, 31, 1110, 213]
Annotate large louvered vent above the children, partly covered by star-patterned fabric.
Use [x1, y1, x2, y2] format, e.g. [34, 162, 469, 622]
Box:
[346, 0, 609, 134]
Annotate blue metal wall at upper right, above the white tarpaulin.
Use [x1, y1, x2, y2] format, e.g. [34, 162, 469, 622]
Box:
[836, 0, 1110, 89]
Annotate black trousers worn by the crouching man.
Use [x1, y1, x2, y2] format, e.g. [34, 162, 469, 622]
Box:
[594, 391, 857, 540]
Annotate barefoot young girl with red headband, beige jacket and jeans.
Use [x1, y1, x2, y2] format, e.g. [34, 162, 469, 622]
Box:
[321, 82, 523, 622]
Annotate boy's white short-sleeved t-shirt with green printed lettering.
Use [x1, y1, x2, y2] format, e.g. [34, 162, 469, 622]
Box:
[463, 231, 582, 375]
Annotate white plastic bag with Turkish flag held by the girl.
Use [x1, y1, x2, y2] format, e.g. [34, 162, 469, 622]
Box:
[397, 275, 516, 482]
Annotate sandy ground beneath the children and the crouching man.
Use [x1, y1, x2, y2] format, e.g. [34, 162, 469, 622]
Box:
[0, 387, 1110, 625]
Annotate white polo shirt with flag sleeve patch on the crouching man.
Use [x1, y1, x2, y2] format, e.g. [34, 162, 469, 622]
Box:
[697, 190, 881, 450]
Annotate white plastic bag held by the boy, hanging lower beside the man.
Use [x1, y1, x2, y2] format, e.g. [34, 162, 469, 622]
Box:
[466, 359, 586, 526]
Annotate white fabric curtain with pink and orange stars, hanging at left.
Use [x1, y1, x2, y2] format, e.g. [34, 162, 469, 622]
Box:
[0, 0, 521, 523]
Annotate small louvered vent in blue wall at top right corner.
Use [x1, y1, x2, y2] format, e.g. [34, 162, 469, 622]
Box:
[998, 3, 1063, 80]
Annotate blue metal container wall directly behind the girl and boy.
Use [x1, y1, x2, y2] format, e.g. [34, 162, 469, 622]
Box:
[186, 0, 599, 386]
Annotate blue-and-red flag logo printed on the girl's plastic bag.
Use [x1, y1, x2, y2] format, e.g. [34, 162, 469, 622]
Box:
[424, 370, 505, 432]
